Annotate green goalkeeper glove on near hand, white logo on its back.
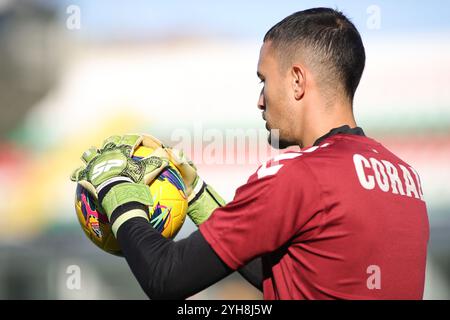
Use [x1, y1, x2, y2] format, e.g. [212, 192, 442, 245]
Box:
[71, 135, 168, 235]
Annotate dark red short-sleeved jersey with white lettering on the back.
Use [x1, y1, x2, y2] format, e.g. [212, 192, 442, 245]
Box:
[200, 134, 429, 299]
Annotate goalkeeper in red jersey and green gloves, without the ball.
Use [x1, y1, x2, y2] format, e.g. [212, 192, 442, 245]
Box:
[72, 8, 429, 299]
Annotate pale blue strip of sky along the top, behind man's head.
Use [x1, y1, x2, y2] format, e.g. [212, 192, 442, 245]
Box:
[51, 0, 450, 40]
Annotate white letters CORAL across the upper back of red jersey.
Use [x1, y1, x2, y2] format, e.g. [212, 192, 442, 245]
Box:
[353, 154, 423, 200]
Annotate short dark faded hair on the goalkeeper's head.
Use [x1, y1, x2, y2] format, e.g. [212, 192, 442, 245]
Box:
[264, 8, 366, 101]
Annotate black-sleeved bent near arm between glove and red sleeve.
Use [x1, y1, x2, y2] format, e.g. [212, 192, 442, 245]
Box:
[117, 208, 233, 299]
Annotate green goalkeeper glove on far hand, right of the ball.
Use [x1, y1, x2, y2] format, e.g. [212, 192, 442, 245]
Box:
[165, 148, 226, 226]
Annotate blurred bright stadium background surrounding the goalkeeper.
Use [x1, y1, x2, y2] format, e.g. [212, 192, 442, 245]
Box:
[0, 0, 450, 299]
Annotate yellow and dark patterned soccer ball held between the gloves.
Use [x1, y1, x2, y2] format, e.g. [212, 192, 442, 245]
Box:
[75, 146, 187, 256]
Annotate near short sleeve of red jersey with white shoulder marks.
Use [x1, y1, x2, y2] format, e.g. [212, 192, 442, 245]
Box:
[199, 157, 319, 270]
